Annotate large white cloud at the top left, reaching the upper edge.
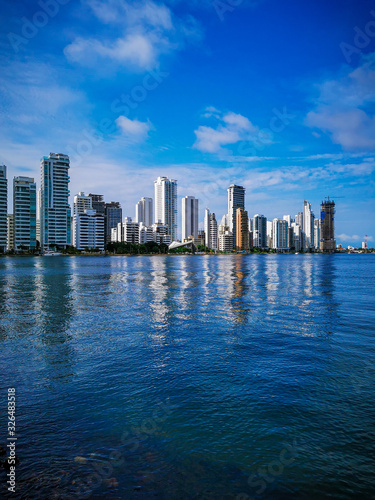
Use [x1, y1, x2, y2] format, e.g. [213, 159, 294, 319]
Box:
[64, 0, 200, 71]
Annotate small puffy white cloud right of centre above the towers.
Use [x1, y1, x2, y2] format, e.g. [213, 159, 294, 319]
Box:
[193, 107, 259, 153]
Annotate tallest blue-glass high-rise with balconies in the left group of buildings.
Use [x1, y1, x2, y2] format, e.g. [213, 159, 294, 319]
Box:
[40, 153, 71, 249]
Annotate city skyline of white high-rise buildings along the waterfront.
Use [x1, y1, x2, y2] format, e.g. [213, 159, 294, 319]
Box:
[0, 153, 372, 252]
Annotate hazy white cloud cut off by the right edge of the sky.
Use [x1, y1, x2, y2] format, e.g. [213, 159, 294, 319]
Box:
[306, 53, 375, 151]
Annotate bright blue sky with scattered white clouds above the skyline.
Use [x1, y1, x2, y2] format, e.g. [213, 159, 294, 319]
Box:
[0, 0, 375, 246]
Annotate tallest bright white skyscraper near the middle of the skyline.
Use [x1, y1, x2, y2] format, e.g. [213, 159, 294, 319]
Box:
[154, 177, 177, 241]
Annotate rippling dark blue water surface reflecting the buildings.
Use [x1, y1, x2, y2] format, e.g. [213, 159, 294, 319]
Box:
[0, 255, 375, 500]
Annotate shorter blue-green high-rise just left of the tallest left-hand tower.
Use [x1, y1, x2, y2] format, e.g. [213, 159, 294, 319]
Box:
[13, 177, 36, 251]
